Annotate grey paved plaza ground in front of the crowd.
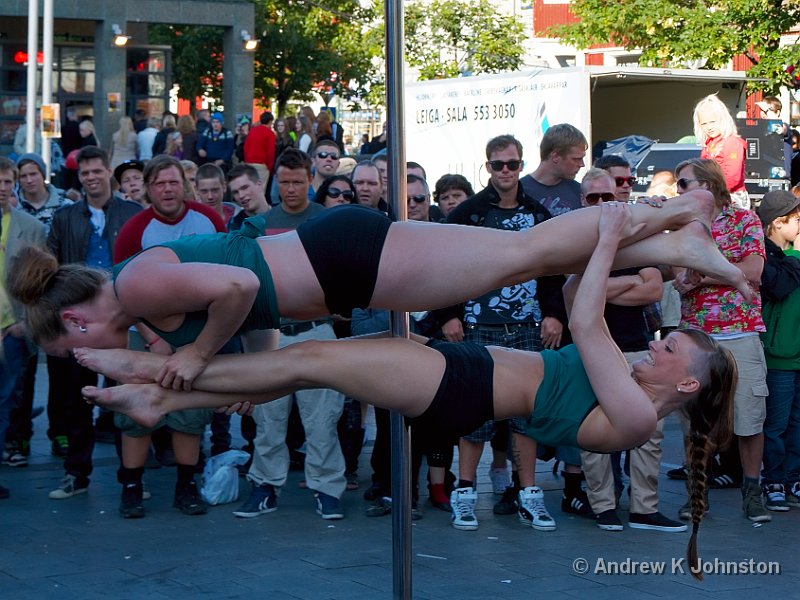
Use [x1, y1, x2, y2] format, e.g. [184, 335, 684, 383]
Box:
[0, 358, 800, 600]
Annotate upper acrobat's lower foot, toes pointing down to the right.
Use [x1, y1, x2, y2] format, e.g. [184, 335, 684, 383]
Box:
[670, 218, 753, 302]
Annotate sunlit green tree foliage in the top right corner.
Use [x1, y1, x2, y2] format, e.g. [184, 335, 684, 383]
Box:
[550, 0, 800, 91]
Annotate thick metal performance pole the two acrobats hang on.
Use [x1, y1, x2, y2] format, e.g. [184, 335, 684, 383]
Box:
[385, 0, 412, 600]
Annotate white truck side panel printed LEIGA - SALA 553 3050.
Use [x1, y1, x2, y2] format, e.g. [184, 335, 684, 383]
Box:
[405, 70, 589, 191]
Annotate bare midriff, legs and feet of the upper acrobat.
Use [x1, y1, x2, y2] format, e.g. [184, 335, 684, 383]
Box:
[259, 190, 750, 320]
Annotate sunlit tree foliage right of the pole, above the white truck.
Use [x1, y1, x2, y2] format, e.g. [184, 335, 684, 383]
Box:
[405, 0, 525, 79]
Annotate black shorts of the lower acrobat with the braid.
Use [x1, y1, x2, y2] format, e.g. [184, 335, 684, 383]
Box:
[409, 340, 494, 437]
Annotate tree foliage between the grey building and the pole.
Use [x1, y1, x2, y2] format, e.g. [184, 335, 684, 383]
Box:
[254, 0, 377, 115]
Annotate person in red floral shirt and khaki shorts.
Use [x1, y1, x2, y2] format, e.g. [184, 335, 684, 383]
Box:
[674, 158, 771, 522]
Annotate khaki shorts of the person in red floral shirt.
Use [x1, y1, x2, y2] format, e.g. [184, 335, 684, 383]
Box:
[717, 335, 769, 436]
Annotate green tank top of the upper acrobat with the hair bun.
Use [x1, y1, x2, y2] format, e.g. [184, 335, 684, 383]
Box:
[112, 230, 280, 347]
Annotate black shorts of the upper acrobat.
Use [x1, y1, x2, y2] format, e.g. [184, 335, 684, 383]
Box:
[297, 204, 392, 315]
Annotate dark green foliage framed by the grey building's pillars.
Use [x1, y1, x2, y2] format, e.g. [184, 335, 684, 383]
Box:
[148, 25, 222, 104]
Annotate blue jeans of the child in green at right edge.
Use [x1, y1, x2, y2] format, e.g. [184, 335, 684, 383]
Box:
[761, 369, 800, 484]
